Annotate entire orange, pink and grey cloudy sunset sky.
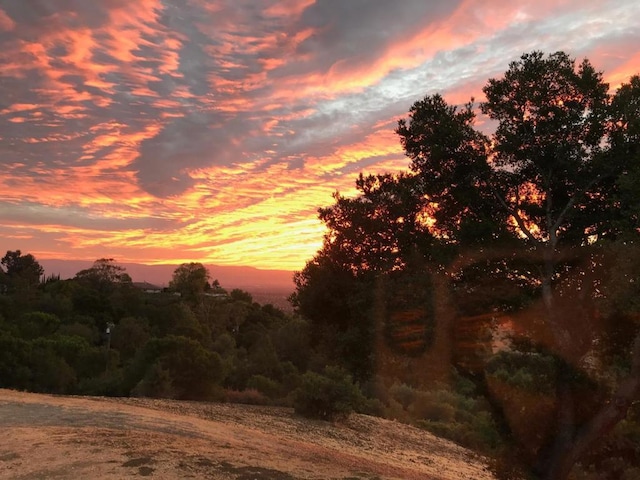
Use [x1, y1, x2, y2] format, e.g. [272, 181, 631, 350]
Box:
[0, 0, 640, 270]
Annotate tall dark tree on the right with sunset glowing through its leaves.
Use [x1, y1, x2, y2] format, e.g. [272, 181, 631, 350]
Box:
[293, 52, 640, 479]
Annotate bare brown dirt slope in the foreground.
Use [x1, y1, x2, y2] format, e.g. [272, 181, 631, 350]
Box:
[0, 389, 493, 480]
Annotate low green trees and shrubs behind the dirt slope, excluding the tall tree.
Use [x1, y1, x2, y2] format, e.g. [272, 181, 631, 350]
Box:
[0, 250, 500, 442]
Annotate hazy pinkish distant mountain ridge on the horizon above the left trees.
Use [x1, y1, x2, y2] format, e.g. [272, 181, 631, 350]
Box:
[38, 259, 295, 292]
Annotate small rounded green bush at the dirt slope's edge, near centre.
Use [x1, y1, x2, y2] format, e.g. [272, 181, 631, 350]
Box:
[294, 367, 366, 420]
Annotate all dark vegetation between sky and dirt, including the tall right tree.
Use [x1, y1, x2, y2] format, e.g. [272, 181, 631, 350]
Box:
[0, 52, 640, 480]
